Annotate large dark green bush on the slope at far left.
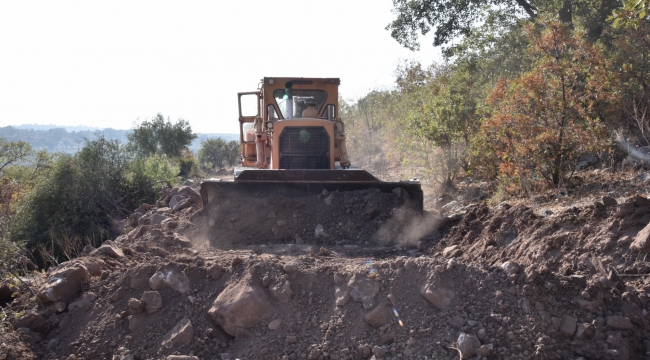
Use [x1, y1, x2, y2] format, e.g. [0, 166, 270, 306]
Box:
[8, 138, 170, 264]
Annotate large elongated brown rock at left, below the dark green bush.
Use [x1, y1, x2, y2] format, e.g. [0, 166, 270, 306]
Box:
[36, 262, 88, 305]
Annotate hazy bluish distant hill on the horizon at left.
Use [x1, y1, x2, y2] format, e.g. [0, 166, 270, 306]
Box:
[0, 125, 239, 154]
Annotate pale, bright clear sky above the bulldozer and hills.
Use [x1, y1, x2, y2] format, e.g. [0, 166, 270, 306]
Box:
[0, 0, 440, 133]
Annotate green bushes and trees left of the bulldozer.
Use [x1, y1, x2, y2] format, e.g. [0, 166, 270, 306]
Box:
[0, 114, 238, 276]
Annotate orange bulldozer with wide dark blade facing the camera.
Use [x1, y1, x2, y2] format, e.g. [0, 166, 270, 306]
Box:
[201, 77, 423, 210]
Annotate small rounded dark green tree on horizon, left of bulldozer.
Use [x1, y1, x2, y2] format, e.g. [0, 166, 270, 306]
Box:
[127, 113, 197, 157]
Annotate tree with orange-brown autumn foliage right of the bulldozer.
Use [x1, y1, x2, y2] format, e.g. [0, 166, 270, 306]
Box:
[479, 22, 616, 186]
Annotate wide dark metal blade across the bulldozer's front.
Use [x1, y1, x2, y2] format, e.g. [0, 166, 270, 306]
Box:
[201, 170, 424, 210]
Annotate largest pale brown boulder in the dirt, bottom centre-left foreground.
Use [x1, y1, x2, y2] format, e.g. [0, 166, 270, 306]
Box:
[208, 281, 273, 338]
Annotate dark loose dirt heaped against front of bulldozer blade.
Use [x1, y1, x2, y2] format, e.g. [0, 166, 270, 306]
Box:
[191, 188, 430, 249]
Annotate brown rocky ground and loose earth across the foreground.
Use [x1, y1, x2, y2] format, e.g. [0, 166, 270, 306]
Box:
[0, 171, 650, 360]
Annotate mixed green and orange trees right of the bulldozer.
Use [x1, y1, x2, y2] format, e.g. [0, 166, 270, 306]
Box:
[341, 0, 650, 199]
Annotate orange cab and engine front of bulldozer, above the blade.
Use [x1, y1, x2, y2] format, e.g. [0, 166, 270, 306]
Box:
[238, 77, 350, 170]
